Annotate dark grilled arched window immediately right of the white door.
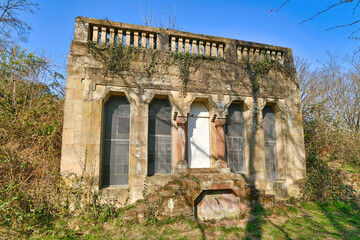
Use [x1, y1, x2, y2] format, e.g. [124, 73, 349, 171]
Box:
[225, 104, 246, 172]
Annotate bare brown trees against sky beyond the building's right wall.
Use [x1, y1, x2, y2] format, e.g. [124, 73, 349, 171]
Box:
[295, 53, 360, 131]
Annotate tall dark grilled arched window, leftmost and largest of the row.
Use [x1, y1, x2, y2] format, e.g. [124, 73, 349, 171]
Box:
[101, 96, 130, 187]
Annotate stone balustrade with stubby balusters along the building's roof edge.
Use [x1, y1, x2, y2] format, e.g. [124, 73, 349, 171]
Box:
[74, 17, 293, 66]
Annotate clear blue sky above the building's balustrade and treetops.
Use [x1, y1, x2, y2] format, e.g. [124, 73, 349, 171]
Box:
[21, 0, 360, 72]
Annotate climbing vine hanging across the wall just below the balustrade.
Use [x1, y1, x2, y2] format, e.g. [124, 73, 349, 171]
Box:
[88, 41, 292, 94]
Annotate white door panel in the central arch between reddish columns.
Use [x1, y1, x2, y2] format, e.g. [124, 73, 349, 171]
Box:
[188, 103, 210, 168]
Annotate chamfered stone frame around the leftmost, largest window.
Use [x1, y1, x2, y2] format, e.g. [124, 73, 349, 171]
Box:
[98, 90, 133, 189]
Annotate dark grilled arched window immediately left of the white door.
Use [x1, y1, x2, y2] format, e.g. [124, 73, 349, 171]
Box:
[148, 99, 172, 176]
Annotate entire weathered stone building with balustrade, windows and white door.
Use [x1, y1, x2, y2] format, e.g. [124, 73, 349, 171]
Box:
[61, 17, 305, 219]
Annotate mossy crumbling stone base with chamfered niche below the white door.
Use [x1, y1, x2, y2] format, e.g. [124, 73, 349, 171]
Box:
[123, 168, 275, 221]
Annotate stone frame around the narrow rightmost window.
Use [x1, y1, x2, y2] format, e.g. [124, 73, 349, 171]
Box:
[261, 98, 287, 182]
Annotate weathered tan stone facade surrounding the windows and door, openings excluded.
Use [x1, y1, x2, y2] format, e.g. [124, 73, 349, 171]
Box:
[61, 17, 305, 218]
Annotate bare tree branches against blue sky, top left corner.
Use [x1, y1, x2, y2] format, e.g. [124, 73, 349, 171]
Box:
[0, 0, 38, 46]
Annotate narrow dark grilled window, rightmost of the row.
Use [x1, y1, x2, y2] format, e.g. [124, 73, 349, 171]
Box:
[263, 106, 279, 180]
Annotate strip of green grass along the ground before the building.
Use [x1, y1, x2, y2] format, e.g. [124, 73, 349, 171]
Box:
[0, 202, 360, 240]
